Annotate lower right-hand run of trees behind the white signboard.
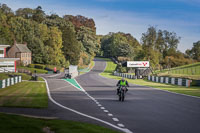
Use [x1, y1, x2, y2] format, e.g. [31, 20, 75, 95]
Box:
[101, 26, 200, 69]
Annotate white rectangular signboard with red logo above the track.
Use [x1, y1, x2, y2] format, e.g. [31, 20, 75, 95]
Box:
[127, 61, 150, 67]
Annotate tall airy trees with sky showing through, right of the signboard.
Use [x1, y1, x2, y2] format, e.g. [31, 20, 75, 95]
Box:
[139, 26, 191, 69]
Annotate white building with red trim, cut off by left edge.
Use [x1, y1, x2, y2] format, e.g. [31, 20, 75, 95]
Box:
[0, 45, 19, 73]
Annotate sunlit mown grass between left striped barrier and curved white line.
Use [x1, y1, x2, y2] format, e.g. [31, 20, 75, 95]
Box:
[0, 81, 48, 108]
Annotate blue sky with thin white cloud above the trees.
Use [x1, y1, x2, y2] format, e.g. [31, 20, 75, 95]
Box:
[0, 0, 200, 52]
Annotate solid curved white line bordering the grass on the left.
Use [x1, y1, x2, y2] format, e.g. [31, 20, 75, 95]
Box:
[43, 78, 132, 133]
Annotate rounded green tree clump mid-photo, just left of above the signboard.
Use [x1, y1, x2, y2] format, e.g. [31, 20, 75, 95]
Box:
[101, 32, 141, 59]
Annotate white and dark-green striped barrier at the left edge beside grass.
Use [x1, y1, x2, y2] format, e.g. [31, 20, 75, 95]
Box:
[0, 76, 22, 88]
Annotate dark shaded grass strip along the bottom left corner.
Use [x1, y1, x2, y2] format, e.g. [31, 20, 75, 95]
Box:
[0, 113, 118, 133]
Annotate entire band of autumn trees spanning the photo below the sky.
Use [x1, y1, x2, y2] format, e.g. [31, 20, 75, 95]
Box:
[0, 4, 200, 69]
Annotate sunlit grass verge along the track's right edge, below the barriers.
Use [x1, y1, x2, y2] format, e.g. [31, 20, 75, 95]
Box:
[100, 59, 200, 97]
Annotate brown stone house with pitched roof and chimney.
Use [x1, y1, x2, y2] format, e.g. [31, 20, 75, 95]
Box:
[7, 43, 32, 66]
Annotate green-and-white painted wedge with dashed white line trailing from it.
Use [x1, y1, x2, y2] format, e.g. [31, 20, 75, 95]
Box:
[63, 79, 132, 133]
